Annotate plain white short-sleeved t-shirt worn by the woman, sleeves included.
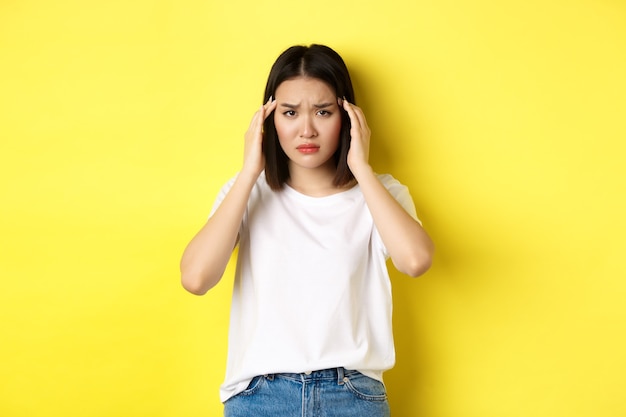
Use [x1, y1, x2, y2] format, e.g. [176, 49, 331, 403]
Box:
[213, 173, 417, 402]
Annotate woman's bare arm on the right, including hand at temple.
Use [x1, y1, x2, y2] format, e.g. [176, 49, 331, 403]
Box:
[343, 100, 434, 277]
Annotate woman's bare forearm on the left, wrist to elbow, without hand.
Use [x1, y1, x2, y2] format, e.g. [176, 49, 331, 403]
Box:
[180, 172, 256, 295]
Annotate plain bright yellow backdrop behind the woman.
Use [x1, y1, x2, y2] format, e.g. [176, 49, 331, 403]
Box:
[0, 0, 626, 417]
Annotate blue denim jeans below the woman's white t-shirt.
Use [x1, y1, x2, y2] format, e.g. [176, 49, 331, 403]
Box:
[224, 368, 389, 417]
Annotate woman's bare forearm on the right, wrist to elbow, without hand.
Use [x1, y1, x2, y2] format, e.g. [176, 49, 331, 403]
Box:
[353, 165, 434, 277]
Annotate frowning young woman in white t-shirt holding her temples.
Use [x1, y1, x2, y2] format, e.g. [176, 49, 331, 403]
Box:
[181, 45, 433, 417]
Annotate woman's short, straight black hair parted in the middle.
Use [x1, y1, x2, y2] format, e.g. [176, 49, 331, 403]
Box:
[263, 44, 355, 190]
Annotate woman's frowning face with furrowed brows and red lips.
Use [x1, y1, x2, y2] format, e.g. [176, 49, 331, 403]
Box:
[274, 77, 341, 172]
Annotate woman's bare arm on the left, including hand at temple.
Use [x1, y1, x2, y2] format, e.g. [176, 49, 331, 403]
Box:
[180, 99, 276, 295]
